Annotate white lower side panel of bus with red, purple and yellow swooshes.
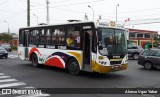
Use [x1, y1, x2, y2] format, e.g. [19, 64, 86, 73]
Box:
[28, 47, 82, 69]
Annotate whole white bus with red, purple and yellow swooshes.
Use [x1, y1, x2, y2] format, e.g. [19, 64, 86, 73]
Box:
[18, 21, 128, 75]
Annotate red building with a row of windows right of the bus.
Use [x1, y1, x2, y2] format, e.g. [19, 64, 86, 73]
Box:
[129, 29, 158, 48]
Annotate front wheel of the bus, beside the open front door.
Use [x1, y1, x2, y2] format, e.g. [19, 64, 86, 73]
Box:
[67, 58, 80, 75]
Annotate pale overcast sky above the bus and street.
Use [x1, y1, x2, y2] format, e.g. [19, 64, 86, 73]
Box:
[0, 0, 160, 33]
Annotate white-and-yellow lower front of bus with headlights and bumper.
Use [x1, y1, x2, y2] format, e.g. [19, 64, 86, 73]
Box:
[92, 49, 128, 73]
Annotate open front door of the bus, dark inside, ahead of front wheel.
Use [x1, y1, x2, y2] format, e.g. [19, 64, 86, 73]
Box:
[83, 29, 92, 70]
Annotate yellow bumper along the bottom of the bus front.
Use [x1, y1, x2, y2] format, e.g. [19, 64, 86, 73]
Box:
[92, 64, 128, 73]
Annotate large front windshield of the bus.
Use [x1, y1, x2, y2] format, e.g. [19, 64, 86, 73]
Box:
[98, 28, 127, 55]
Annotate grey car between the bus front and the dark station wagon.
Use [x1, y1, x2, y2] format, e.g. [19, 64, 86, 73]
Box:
[128, 45, 144, 59]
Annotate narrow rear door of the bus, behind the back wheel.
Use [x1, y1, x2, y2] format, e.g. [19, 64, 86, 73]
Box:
[24, 30, 29, 59]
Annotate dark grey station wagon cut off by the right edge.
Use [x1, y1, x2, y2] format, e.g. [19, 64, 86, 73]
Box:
[138, 49, 160, 70]
